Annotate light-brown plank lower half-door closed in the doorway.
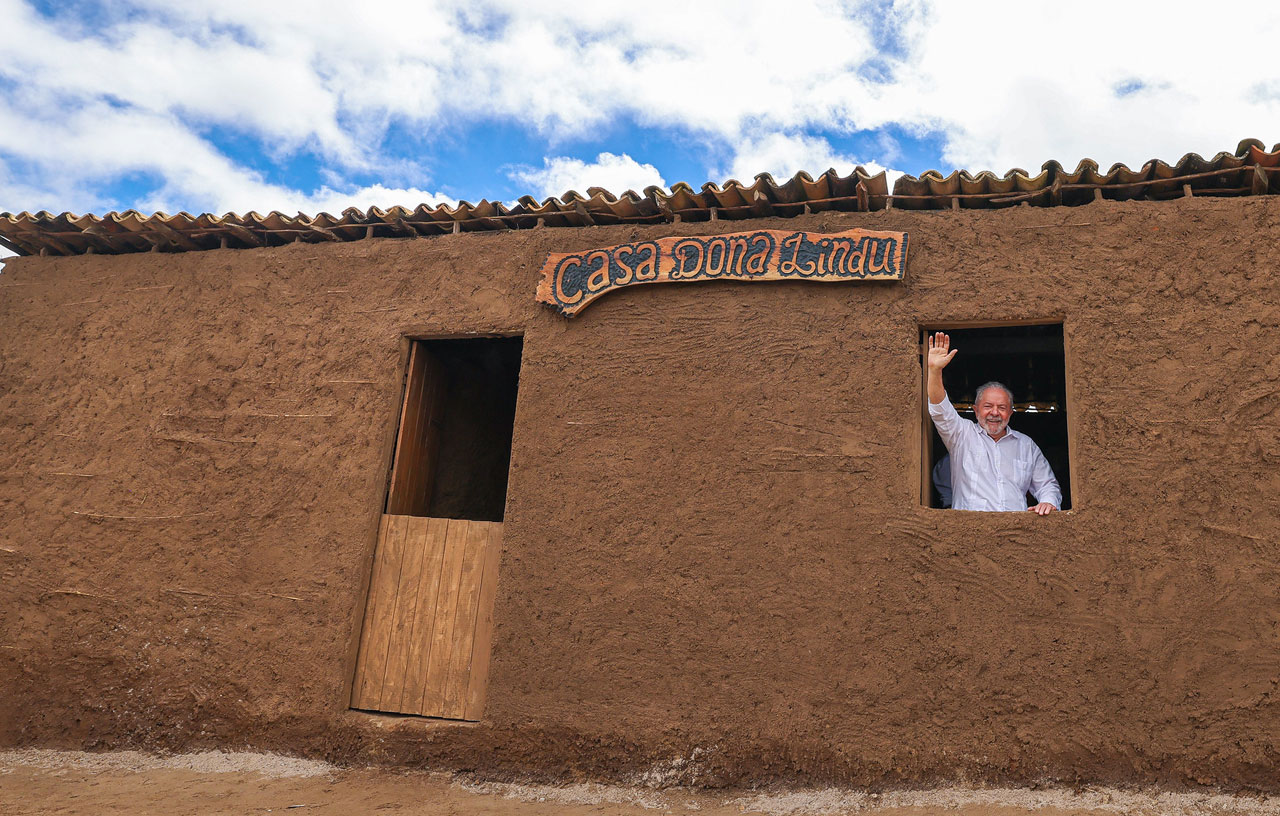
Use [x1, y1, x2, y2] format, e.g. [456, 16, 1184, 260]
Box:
[351, 514, 502, 720]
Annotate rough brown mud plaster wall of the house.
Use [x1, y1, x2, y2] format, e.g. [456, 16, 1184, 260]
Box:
[0, 198, 1280, 790]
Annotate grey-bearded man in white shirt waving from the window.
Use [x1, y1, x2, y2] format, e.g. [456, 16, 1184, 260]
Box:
[925, 331, 1062, 515]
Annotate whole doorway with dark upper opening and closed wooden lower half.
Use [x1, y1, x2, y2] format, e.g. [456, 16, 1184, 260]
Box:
[351, 338, 522, 720]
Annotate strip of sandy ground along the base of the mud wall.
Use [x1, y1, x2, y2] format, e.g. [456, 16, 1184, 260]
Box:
[0, 749, 1280, 816]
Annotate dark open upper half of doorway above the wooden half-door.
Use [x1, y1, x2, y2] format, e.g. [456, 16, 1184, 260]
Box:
[387, 338, 524, 522]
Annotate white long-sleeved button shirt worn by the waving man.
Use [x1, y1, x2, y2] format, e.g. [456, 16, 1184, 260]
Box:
[929, 396, 1062, 510]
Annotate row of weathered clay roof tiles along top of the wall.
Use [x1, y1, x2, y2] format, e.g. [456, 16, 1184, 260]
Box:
[0, 139, 1280, 255]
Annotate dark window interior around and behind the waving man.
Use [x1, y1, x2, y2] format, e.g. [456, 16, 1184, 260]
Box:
[920, 324, 1071, 510]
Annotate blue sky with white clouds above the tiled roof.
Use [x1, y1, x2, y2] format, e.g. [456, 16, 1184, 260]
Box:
[0, 0, 1280, 230]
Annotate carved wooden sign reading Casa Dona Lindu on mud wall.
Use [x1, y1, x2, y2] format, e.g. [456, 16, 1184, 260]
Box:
[538, 229, 906, 317]
